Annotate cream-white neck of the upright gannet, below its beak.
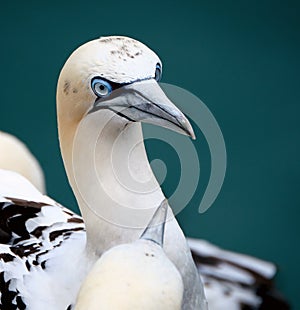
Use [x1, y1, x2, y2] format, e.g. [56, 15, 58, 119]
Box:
[59, 110, 164, 255]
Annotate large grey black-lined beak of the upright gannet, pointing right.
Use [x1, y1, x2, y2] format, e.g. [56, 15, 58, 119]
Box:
[89, 79, 195, 139]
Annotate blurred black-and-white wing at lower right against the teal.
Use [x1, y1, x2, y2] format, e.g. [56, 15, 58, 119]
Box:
[188, 239, 289, 310]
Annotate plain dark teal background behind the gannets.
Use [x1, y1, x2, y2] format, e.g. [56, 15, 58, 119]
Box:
[0, 0, 300, 309]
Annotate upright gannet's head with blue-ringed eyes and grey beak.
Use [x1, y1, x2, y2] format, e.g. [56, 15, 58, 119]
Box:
[57, 36, 194, 137]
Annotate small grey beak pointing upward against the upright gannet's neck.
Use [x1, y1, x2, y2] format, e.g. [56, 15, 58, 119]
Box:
[140, 199, 169, 247]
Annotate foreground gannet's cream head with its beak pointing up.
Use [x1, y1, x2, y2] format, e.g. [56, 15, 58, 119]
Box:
[75, 201, 183, 310]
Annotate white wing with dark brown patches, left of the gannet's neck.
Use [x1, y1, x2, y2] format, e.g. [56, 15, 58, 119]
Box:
[0, 170, 86, 310]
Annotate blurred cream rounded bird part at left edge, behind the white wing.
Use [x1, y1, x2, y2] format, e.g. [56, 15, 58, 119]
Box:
[0, 131, 45, 193]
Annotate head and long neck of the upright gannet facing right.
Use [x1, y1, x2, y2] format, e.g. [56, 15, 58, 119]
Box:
[57, 36, 207, 310]
